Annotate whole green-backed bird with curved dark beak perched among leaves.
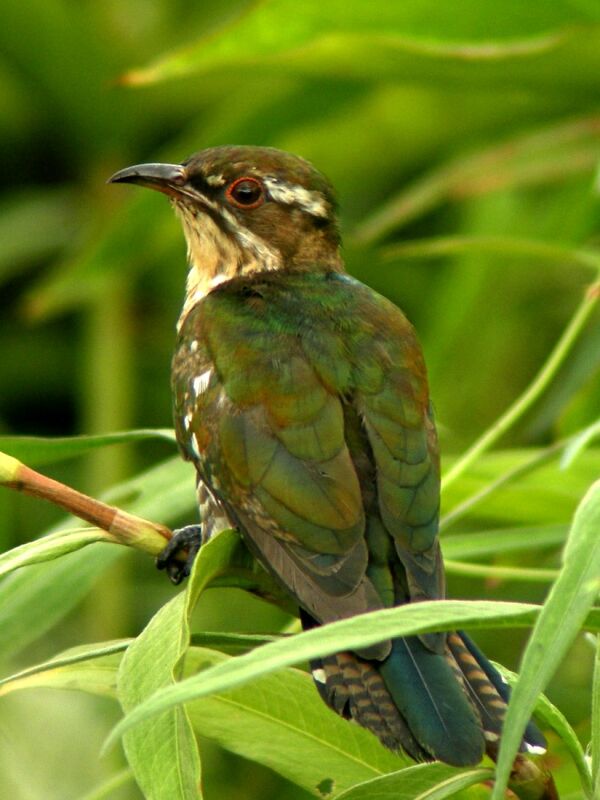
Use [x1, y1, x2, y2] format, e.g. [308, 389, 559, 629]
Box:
[109, 145, 556, 798]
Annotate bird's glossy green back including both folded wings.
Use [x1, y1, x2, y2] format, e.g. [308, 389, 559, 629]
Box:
[174, 276, 443, 658]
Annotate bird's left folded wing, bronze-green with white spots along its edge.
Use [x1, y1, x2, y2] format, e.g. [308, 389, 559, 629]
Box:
[173, 282, 389, 658]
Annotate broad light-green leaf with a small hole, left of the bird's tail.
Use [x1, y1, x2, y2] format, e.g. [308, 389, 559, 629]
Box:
[185, 648, 406, 797]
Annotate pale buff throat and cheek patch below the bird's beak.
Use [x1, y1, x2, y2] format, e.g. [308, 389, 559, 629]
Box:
[173, 202, 281, 331]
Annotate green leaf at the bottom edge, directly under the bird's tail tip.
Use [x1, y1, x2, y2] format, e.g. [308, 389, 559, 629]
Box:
[336, 763, 494, 800]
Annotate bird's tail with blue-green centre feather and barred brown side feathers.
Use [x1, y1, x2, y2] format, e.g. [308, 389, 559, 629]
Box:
[302, 612, 545, 766]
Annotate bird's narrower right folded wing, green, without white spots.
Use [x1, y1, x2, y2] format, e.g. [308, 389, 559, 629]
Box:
[356, 295, 445, 600]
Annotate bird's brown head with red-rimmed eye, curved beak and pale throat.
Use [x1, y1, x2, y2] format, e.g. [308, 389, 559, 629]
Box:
[109, 146, 342, 320]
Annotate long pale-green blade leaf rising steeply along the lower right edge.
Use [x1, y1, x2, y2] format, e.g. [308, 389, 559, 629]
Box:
[493, 482, 600, 800]
